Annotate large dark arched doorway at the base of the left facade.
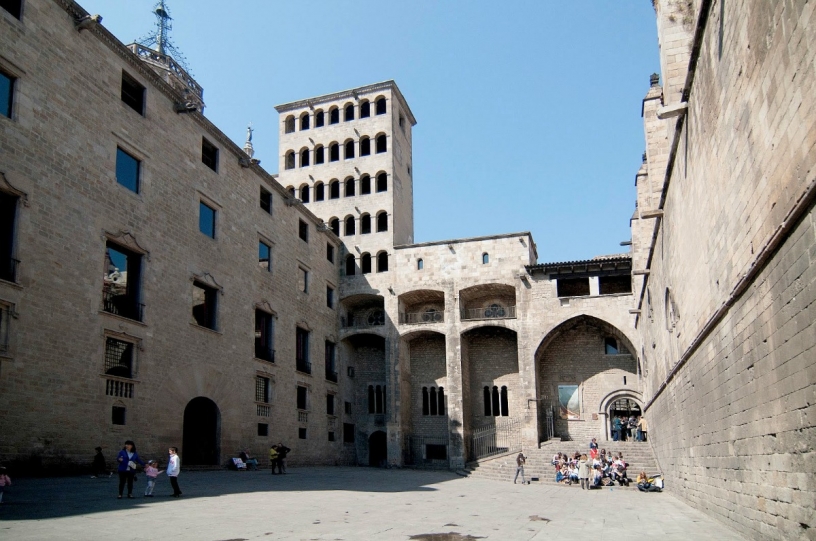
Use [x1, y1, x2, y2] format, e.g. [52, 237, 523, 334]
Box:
[181, 396, 221, 466]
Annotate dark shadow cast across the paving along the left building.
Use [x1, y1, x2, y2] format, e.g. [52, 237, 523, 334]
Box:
[0, 467, 460, 521]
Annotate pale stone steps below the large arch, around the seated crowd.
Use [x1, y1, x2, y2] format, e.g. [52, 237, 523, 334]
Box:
[462, 440, 660, 486]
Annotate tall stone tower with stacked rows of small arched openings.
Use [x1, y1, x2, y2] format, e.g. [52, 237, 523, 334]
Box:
[275, 81, 416, 275]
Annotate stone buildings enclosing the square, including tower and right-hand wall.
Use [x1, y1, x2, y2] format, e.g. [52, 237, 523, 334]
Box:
[0, 0, 816, 539]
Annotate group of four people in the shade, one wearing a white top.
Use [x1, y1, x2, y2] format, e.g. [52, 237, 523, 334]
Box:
[91, 440, 181, 500]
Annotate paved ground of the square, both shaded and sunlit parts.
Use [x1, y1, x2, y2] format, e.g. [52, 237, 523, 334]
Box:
[0, 468, 741, 541]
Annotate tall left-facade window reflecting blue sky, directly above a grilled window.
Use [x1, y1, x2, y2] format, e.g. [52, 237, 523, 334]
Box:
[102, 241, 144, 321]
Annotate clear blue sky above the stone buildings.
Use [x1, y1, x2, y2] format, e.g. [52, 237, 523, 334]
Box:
[80, 0, 659, 262]
